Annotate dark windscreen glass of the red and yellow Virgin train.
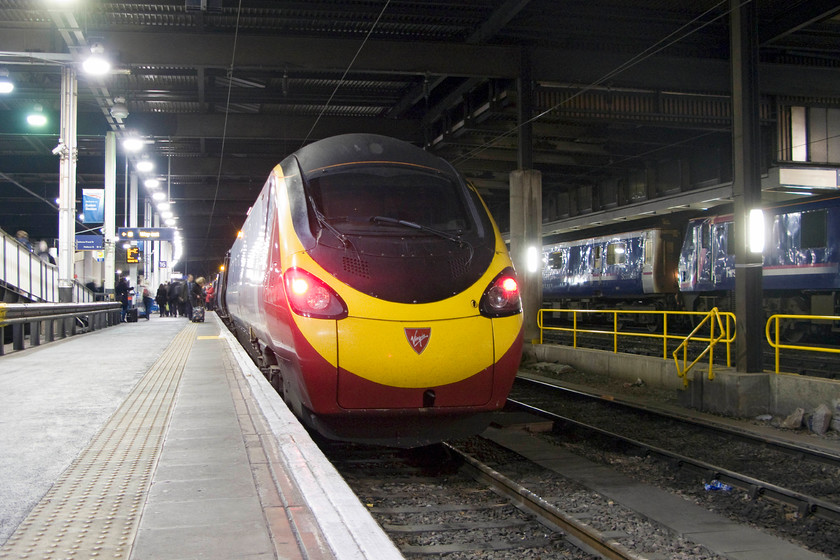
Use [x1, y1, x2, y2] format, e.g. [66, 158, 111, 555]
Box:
[308, 166, 472, 234]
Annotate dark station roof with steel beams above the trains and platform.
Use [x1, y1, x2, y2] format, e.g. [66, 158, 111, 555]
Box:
[0, 0, 840, 273]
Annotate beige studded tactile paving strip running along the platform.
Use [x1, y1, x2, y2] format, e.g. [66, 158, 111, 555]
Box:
[0, 324, 196, 559]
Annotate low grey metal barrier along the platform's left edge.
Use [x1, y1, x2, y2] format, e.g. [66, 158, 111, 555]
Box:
[0, 302, 122, 356]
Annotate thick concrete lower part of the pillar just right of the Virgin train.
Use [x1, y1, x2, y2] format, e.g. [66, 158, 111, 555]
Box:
[510, 169, 542, 341]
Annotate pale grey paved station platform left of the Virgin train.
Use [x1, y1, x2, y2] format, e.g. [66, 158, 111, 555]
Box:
[0, 313, 402, 560]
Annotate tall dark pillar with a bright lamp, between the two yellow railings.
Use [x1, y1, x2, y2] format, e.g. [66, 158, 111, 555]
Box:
[730, 0, 764, 373]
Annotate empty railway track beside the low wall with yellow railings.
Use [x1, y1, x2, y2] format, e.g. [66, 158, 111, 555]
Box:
[509, 378, 840, 551]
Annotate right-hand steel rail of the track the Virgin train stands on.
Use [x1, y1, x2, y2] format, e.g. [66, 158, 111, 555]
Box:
[443, 443, 644, 560]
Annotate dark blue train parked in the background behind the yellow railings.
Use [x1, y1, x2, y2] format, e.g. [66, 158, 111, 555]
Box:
[543, 192, 840, 340]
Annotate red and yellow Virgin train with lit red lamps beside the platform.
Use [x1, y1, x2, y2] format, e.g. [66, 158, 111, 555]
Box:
[219, 134, 522, 447]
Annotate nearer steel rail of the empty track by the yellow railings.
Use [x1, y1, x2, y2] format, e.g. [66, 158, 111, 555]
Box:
[508, 392, 840, 523]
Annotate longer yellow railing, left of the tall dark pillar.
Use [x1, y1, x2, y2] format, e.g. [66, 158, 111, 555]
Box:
[537, 309, 735, 368]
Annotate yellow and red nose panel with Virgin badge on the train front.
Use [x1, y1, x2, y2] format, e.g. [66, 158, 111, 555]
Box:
[338, 317, 494, 409]
